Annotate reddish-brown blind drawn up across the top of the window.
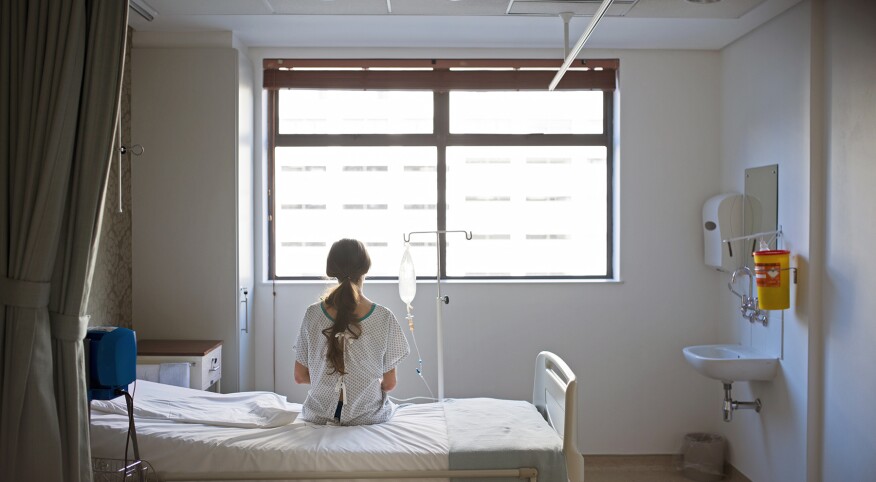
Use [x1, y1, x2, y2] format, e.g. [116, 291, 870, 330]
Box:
[264, 59, 618, 91]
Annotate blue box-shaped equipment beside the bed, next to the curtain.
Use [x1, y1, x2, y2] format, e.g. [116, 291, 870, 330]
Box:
[84, 326, 137, 402]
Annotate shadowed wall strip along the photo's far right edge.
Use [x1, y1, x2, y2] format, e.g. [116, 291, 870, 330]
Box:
[821, 0, 876, 481]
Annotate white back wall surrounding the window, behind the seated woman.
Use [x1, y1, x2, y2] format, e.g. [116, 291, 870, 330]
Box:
[250, 49, 723, 454]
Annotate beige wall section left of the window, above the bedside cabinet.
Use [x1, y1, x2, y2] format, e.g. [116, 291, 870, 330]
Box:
[131, 32, 253, 391]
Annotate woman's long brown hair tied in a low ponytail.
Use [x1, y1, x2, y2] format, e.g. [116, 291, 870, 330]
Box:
[322, 238, 371, 374]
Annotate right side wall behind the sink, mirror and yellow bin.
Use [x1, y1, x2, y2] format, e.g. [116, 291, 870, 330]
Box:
[713, 1, 812, 481]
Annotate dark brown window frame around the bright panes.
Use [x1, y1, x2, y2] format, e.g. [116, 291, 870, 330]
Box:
[265, 60, 618, 281]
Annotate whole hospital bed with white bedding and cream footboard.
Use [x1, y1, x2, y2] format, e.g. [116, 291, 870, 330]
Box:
[91, 352, 584, 482]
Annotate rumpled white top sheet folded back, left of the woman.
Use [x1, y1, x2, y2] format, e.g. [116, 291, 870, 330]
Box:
[91, 380, 301, 428]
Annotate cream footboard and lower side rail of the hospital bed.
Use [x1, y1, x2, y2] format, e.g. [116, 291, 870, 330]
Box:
[158, 351, 584, 482]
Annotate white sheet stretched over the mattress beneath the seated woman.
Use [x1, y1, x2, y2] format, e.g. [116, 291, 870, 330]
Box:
[91, 381, 449, 480]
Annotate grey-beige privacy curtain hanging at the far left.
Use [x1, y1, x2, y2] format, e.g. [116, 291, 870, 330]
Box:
[0, 0, 128, 482]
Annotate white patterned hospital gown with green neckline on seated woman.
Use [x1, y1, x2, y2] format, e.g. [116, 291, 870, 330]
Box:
[294, 302, 411, 425]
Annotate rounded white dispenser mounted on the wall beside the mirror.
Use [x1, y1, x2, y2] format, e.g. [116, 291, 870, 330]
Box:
[703, 193, 746, 272]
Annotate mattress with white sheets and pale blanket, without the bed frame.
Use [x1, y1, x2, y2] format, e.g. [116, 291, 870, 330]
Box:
[91, 380, 566, 482]
